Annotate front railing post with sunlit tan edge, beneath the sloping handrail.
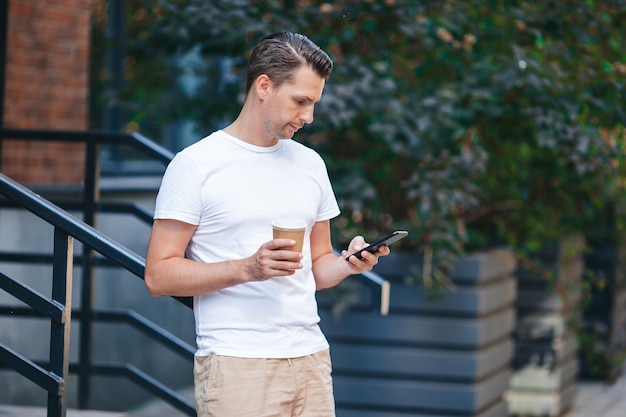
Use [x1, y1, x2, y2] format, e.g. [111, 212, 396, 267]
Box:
[48, 228, 74, 417]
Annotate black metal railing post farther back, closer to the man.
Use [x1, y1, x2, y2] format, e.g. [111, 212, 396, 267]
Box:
[78, 140, 100, 409]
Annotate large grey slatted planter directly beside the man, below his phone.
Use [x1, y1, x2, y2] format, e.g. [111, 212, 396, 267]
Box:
[320, 251, 516, 417]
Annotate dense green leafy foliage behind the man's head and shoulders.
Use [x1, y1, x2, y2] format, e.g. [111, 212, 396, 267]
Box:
[89, 0, 626, 276]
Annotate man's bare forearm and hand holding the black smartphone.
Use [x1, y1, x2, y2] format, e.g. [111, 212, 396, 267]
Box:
[311, 220, 389, 290]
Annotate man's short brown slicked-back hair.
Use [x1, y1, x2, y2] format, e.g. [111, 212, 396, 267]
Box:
[246, 32, 333, 93]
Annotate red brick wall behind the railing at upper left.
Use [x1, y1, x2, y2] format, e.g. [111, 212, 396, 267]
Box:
[0, 0, 91, 184]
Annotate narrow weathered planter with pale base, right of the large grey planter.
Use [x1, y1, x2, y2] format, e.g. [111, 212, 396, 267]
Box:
[506, 237, 585, 417]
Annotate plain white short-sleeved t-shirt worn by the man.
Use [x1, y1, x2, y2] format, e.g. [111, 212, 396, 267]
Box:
[154, 131, 339, 358]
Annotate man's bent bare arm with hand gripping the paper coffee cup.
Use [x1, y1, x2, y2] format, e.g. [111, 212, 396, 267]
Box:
[145, 219, 302, 296]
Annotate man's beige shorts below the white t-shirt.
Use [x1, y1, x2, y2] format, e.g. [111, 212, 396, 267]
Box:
[194, 350, 335, 417]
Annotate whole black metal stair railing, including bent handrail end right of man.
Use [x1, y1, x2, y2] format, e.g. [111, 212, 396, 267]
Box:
[0, 129, 389, 417]
